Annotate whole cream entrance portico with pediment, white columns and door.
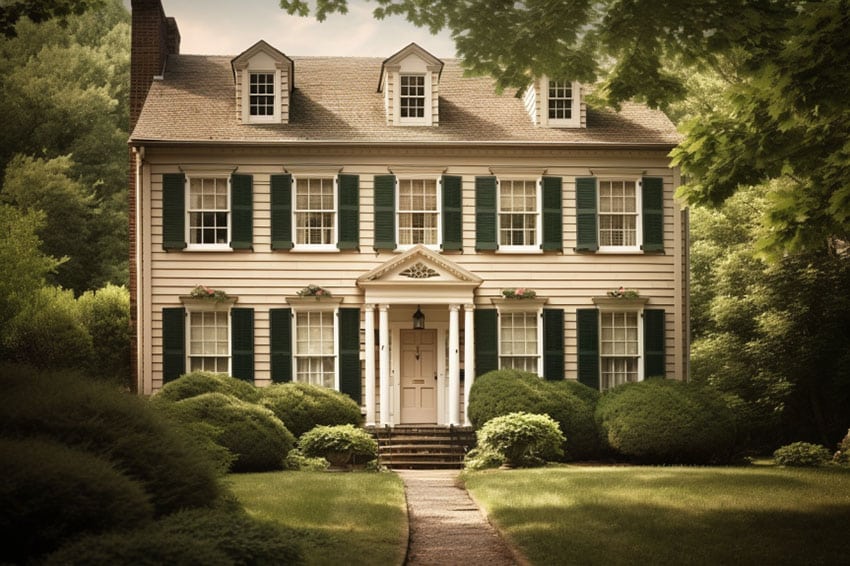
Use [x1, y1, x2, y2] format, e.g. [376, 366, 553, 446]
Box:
[357, 245, 482, 426]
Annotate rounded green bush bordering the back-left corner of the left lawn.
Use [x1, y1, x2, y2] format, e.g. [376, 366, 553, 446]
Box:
[169, 393, 295, 472]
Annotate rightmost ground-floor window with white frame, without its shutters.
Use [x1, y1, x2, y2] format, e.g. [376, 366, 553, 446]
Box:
[599, 311, 641, 391]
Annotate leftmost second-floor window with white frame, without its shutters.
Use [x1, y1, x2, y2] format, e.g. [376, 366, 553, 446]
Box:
[187, 177, 230, 249]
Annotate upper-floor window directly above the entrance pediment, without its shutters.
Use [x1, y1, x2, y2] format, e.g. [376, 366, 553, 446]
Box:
[397, 179, 440, 247]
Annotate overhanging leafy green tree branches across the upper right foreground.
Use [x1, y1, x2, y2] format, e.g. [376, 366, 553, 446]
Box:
[280, 0, 850, 252]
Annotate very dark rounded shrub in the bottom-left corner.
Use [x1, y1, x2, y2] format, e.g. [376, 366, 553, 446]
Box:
[0, 438, 154, 564]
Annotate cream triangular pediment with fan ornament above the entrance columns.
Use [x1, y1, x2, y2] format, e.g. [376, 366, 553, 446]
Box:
[357, 245, 482, 287]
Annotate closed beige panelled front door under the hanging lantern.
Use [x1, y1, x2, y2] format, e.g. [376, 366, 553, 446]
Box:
[400, 329, 437, 424]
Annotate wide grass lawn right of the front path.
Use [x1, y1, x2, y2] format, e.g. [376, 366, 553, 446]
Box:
[463, 466, 850, 566]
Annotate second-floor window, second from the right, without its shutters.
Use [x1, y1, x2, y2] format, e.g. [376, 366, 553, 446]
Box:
[498, 179, 540, 250]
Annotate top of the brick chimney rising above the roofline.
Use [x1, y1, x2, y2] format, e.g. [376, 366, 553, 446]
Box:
[130, 0, 180, 132]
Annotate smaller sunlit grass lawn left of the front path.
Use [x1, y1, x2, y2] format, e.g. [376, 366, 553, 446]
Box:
[229, 472, 407, 566]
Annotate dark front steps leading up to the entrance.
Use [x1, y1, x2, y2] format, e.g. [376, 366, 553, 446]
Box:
[366, 425, 475, 470]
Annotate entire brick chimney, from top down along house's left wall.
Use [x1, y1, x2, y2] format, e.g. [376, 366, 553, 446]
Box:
[127, 0, 180, 393]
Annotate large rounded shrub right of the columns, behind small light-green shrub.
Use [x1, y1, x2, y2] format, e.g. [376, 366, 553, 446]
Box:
[469, 369, 600, 459]
